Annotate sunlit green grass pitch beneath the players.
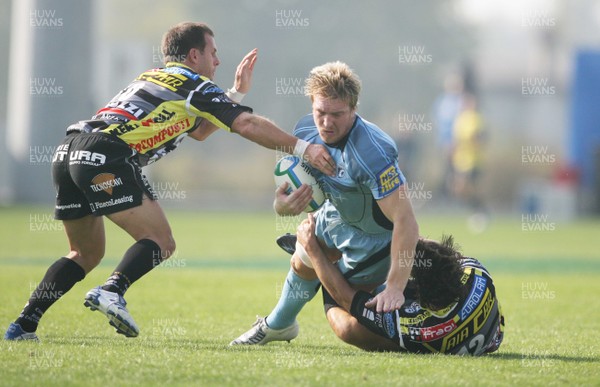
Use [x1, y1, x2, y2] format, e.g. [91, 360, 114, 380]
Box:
[0, 208, 600, 386]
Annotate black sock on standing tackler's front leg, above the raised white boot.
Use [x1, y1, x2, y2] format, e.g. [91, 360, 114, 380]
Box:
[102, 239, 162, 296]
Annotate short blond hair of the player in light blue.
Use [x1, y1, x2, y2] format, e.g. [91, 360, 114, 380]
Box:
[304, 61, 361, 109]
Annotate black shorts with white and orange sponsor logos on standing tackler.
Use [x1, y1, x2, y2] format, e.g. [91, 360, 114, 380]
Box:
[52, 132, 156, 220]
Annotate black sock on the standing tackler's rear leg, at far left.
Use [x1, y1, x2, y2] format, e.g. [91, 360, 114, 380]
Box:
[15, 257, 85, 332]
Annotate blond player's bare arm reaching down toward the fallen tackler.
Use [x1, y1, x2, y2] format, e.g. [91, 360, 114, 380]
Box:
[366, 185, 419, 312]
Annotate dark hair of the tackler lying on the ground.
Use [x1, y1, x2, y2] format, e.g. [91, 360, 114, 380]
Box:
[411, 235, 468, 310]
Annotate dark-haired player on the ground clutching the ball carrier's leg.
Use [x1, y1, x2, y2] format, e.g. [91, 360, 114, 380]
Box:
[297, 215, 504, 356]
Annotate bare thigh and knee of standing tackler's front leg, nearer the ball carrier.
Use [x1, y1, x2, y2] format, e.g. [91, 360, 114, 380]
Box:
[106, 197, 175, 258]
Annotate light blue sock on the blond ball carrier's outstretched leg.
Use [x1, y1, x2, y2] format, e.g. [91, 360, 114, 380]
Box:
[266, 269, 319, 329]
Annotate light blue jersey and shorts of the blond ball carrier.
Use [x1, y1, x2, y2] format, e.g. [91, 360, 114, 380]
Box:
[294, 115, 405, 284]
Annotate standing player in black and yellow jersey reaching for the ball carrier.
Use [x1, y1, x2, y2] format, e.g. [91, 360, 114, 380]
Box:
[4, 22, 335, 340]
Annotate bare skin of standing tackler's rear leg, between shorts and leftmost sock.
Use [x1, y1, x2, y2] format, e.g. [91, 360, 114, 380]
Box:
[63, 215, 106, 274]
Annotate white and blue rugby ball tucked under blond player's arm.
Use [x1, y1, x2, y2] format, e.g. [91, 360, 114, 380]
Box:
[275, 155, 325, 212]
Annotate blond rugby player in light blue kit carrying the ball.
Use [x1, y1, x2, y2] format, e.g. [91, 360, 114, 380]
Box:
[230, 62, 419, 345]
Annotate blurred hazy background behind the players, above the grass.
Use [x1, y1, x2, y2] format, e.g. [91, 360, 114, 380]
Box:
[0, 0, 600, 226]
